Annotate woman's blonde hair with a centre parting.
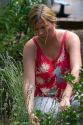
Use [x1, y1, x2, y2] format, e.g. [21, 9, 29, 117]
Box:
[29, 4, 56, 27]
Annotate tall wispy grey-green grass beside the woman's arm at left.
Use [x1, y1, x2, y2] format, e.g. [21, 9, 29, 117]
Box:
[0, 54, 28, 125]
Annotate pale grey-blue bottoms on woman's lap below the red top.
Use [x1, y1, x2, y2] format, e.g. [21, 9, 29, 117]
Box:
[33, 97, 80, 115]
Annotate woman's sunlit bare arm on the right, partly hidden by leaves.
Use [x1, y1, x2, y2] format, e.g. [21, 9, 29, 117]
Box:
[59, 31, 82, 109]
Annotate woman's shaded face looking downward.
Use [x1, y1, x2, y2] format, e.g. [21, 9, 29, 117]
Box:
[35, 19, 55, 39]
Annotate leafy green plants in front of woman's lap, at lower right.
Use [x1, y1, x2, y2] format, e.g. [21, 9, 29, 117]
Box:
[35, 71, 83, 125]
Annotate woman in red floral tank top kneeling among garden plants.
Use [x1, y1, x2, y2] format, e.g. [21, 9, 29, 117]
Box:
[23, 4, 81, 124]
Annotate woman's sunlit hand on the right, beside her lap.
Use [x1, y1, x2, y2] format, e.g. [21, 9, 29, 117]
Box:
[59, 97, 70, 111]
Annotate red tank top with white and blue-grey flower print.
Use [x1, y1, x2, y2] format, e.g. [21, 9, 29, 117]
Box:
[33, 32, 70, 100]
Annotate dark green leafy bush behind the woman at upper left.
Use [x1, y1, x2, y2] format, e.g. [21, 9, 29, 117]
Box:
[0, 0, 46, 60]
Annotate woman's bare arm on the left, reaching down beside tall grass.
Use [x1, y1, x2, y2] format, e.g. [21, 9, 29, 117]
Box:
[23, 42, 35, 115]
